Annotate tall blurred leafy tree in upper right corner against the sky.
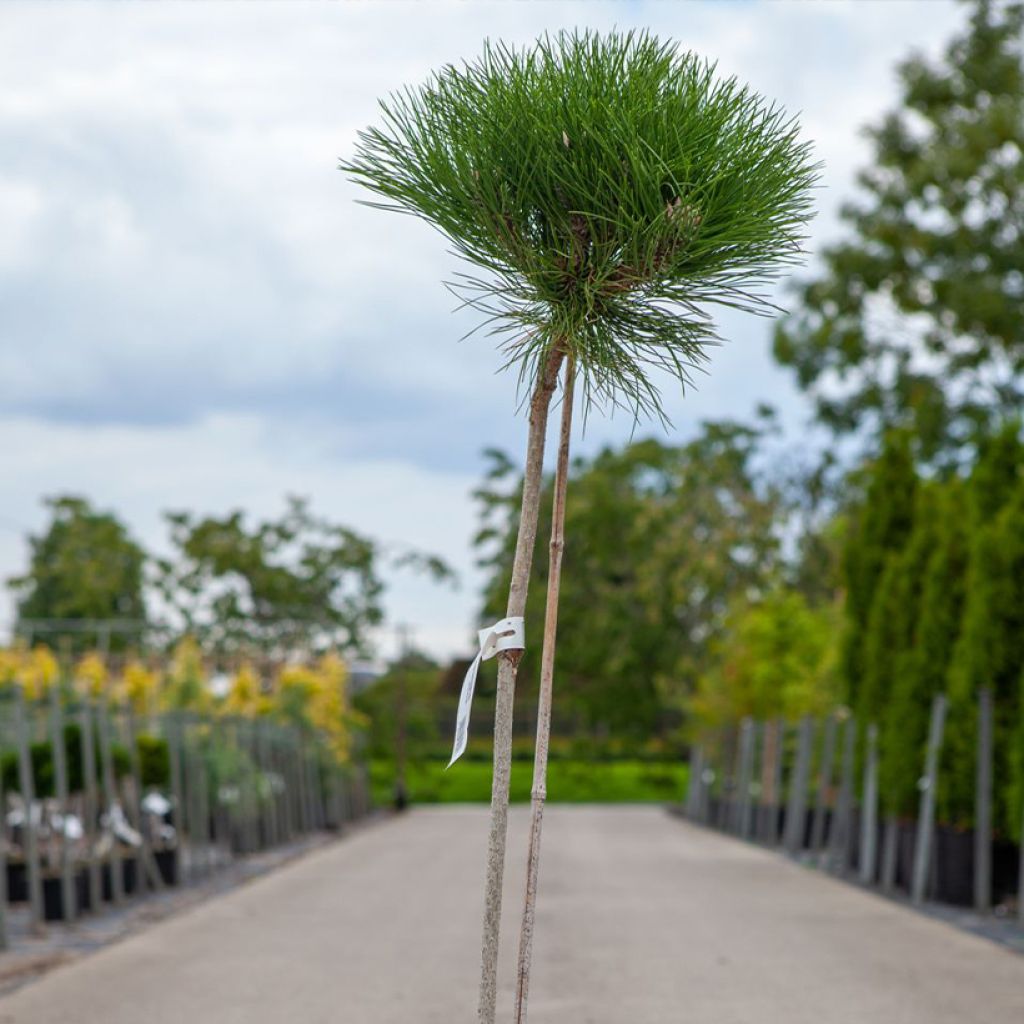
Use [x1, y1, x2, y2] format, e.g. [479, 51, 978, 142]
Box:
[775, 0, 1024, 459]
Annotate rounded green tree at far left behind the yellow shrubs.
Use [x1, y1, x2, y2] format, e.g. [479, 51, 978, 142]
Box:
[8, 495, 145, 650]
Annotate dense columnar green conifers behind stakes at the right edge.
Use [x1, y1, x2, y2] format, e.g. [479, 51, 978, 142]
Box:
[843, 421, 1024, 833]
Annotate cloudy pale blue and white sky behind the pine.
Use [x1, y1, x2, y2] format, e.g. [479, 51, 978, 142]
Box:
[0, 0, 965, 655]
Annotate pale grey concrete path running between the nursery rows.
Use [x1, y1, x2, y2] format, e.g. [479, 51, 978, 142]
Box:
[0, 807, 1024, 1024]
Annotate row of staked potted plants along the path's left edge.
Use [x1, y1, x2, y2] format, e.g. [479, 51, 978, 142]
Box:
[0, 686, 370, 945]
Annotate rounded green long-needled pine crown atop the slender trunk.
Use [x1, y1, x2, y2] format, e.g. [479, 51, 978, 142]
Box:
[342, 32, 817, 416]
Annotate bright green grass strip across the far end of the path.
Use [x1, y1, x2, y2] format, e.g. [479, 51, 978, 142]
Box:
[370, 760, 686, 805]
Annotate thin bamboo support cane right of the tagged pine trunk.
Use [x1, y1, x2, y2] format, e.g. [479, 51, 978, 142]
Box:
[515, 354, 575, 1024]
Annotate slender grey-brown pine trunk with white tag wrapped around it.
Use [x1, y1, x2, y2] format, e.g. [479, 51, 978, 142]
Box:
[478, 346, 564, 1024]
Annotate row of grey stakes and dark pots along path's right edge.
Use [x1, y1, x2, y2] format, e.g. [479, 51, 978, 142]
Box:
[684, 690, 1024, 923]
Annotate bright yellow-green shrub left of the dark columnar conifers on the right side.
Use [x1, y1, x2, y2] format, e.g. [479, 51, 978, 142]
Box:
[689, 587, 839, 728]
